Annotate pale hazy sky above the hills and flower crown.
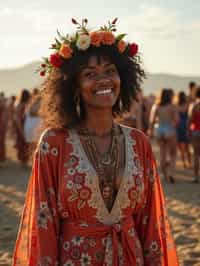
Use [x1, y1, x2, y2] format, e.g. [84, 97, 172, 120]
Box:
[0, 0, 200, 75]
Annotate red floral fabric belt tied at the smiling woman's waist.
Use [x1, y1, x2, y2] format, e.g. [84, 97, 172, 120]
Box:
[63, 217, 138, 266]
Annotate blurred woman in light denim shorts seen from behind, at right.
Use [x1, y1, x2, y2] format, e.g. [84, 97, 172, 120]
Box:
[150, 89, 178, 183]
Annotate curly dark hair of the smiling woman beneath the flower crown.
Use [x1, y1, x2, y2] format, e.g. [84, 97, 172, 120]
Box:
[41, 45, 145, 128]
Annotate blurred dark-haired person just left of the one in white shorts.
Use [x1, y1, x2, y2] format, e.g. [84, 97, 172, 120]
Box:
[14, 89, 30, 166]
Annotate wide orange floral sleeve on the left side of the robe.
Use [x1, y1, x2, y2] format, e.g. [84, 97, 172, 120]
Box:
[13, 132, 59, 266]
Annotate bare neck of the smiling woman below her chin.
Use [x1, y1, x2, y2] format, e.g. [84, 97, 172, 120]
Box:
[81, 110, 113, 136]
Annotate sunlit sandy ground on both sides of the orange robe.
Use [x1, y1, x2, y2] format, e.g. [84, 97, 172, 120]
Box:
[0, 139, 200, 266]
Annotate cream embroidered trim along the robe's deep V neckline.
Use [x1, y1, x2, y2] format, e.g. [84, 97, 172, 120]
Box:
[67, 126, 144, 224]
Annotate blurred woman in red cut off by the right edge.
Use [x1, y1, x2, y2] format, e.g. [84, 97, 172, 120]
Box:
[188, 87, 200, 183]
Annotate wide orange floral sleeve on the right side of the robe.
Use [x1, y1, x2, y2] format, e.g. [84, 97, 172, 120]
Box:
[135, 141, 179, 266]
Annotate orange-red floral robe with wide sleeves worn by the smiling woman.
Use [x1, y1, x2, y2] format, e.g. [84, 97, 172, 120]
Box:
[13, 126, 178, 266]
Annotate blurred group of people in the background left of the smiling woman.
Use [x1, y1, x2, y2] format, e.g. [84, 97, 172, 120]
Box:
[0, 88, 41, 167]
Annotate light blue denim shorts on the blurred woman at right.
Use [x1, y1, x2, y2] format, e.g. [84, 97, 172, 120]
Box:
[154, 123, 176, 138]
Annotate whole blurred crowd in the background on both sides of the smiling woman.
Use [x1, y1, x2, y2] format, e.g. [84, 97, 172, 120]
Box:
[0, 81, 200, 183]
